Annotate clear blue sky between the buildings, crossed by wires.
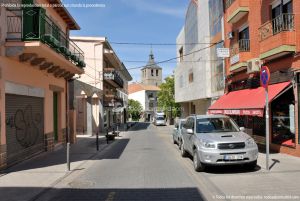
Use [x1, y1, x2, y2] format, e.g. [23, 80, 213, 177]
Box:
[63, 0, 189, 81]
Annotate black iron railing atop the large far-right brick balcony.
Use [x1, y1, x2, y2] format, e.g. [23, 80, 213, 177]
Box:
[259, 13, 295, 41]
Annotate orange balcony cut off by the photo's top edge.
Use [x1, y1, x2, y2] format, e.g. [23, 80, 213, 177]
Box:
[225, 0, 249, 24]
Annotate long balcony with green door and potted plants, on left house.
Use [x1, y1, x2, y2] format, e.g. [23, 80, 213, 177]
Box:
[5, 7, 85, 78]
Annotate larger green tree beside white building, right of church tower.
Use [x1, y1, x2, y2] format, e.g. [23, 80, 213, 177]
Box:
[158, 76, 180, 118]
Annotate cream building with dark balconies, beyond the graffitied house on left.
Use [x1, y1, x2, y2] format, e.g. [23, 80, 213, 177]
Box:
[72, 37, 132, 133]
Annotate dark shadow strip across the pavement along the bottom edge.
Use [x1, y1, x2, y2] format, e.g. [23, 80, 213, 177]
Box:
[0, 187, 204, 201]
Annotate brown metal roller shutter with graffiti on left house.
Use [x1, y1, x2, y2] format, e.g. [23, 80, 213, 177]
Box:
[5, 94, 44, 165]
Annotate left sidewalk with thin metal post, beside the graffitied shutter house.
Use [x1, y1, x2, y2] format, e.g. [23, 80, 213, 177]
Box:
[0, 133, 111, 201]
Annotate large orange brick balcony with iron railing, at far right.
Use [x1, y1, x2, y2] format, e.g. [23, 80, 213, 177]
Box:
[259, 14, 296, 61]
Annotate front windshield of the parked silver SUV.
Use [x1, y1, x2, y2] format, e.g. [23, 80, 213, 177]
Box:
[196, 118, 239, 133]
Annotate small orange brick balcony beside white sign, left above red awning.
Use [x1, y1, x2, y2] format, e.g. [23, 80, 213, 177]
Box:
[229, 39, 251, 73]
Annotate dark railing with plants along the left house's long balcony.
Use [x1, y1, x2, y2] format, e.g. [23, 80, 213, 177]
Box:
[7, 8, 85, 68]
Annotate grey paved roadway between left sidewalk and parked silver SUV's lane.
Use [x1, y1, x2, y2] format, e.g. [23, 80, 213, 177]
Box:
[38, 123, 203, 201]
